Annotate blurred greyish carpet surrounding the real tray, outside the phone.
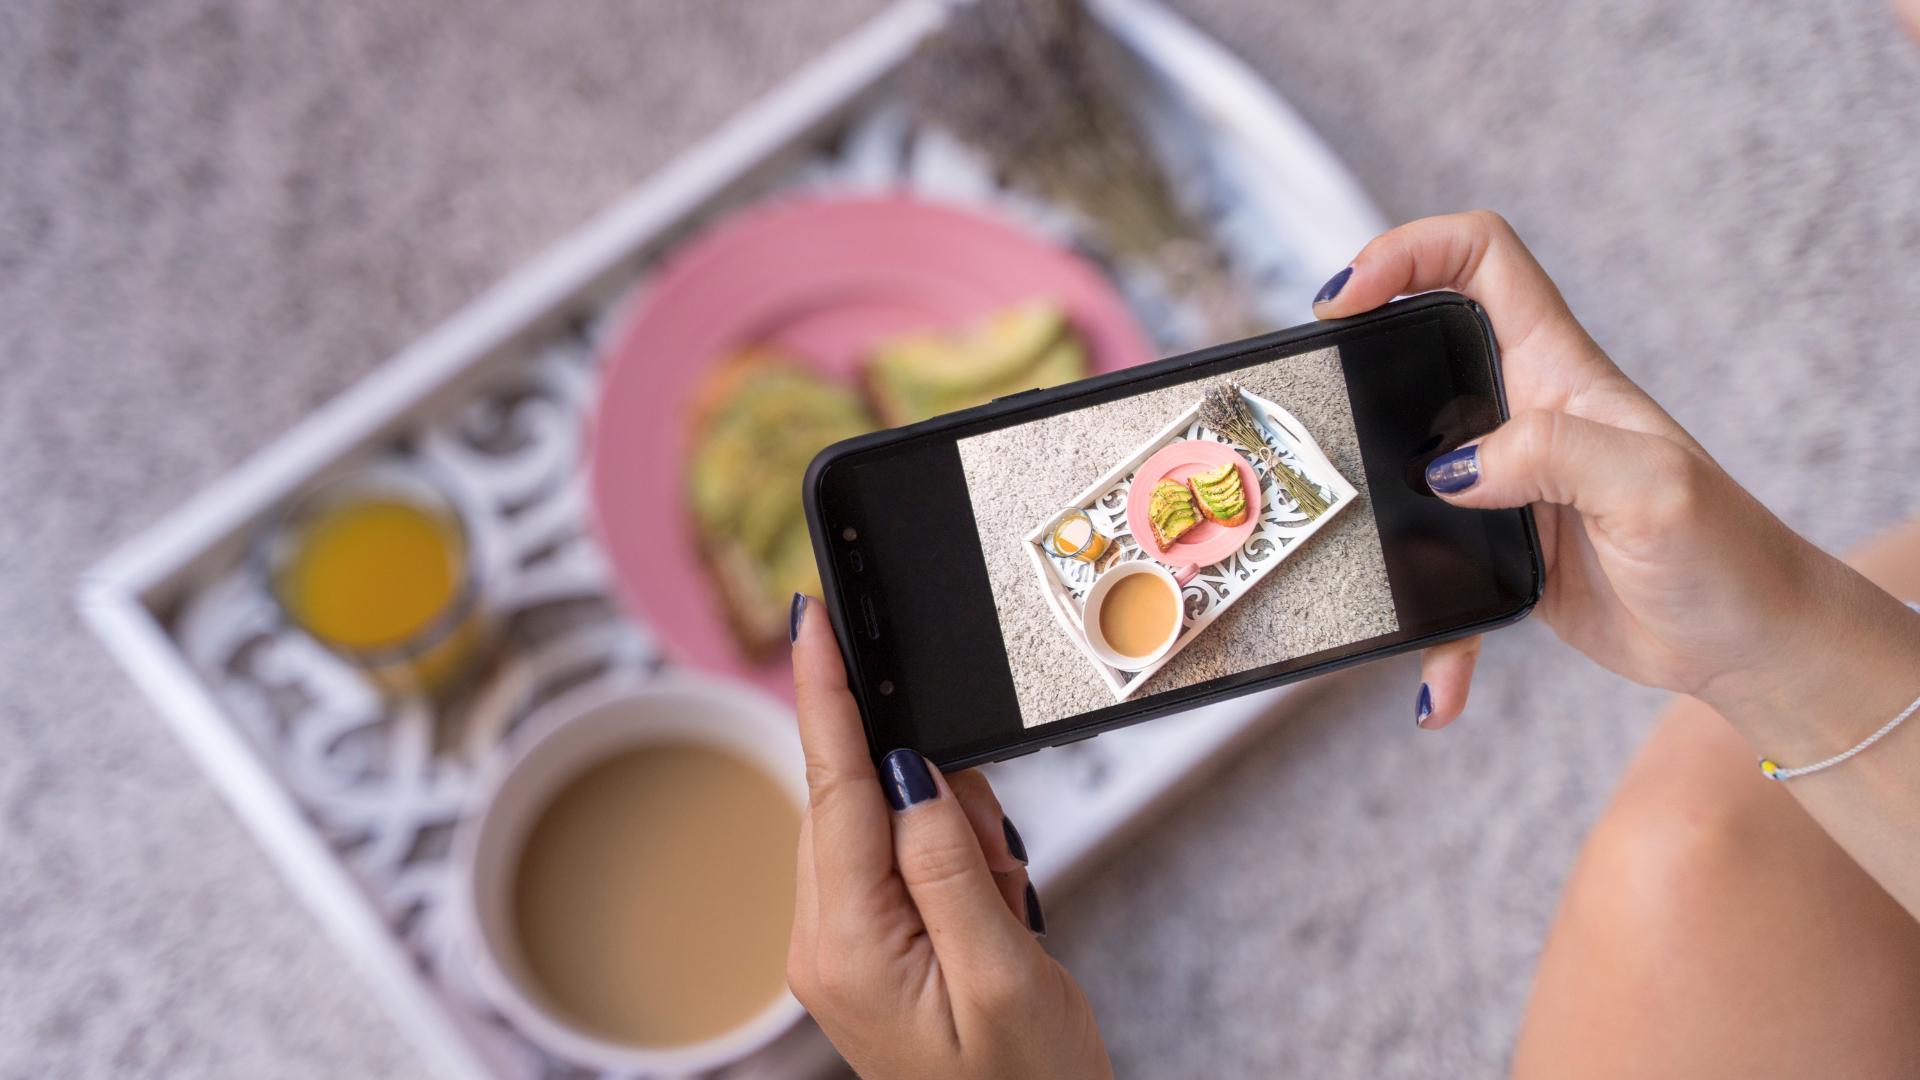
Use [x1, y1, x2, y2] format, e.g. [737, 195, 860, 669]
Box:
[0, 0, 1920, 1078]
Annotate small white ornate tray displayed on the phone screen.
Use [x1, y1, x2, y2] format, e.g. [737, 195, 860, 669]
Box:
[1027, 390, 1359, 701]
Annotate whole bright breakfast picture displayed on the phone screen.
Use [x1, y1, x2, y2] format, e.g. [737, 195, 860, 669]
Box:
[958, 348, 1400, 728]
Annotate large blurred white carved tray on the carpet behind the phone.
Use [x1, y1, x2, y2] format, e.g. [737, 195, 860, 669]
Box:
[77, 0, 1382, 1078]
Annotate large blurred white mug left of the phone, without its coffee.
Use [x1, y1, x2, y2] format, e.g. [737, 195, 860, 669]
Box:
[453, 675, 806, 1074]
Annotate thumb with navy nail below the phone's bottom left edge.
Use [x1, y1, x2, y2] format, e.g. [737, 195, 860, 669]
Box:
[879, 749, 1039, 986]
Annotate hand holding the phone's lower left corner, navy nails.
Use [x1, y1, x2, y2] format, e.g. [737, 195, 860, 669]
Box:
[787, 596, 1114, 1080]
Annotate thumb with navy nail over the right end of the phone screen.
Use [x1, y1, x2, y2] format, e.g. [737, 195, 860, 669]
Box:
[1427, 409, 1688, 523]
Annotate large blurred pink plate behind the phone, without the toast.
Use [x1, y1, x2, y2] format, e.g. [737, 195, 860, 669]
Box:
[588, 196, 1152, 696]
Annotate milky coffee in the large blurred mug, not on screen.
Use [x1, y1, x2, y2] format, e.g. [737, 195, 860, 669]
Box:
[515, 744, 799, 1047]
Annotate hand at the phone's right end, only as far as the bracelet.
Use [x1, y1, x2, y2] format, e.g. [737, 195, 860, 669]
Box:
[1315, 211, 1897, 728]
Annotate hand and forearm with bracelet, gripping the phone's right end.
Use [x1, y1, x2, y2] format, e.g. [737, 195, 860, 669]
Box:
[1313, 211, 1920, 907]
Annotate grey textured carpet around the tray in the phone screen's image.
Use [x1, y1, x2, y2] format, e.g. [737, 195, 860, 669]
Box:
[960, 350, 1400, 728]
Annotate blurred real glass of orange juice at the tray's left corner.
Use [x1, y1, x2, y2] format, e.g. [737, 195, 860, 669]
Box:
[265, 465, 482, 692]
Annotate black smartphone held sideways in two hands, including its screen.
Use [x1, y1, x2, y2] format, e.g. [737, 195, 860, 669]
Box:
[804, 292, 1544, 769]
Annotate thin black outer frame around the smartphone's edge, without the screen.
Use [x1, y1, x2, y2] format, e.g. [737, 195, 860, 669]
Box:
[803, 292, 1546, 771]
